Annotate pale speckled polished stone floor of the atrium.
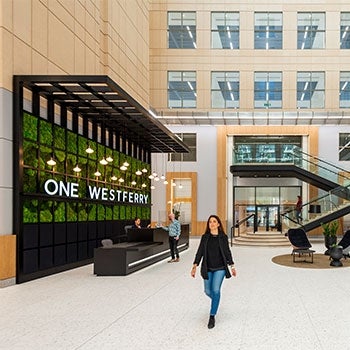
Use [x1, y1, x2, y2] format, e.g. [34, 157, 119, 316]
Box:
[0, 239, 350, 350]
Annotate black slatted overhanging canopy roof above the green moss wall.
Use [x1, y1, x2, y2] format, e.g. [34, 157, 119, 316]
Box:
[14, 75, 189, 153]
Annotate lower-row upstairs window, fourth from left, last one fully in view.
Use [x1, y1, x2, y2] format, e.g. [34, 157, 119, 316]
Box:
[297, 72, 325, 108]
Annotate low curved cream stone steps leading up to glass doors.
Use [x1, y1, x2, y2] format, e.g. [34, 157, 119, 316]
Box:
[232, 232, 291, 247]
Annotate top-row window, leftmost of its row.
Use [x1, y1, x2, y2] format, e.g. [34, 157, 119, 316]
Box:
[168, 12, 197, 49]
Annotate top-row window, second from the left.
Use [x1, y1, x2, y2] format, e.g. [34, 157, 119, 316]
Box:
[211, 12, 239, 50]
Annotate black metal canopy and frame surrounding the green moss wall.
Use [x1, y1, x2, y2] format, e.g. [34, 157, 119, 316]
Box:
[13, 75, 188, 282]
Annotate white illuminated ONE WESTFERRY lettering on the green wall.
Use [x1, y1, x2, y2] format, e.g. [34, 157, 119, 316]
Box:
[44, 179, 148, 204]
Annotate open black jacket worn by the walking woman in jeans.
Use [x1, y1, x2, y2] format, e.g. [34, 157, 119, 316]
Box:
[193, 232, 233, 280]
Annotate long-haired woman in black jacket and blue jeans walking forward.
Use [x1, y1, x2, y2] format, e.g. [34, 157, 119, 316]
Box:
[191, 215, 236, 329]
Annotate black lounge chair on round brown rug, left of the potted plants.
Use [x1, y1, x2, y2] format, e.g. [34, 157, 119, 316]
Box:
[288, 228, 315, 263]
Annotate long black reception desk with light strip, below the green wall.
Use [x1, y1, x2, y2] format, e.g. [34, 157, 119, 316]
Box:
[94, 224, 189, 276]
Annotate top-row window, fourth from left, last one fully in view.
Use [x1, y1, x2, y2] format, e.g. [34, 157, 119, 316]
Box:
[298, 12, 326, 50]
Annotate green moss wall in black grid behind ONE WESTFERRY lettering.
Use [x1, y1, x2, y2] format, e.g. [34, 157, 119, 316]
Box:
[22, 113, 151, 224]
